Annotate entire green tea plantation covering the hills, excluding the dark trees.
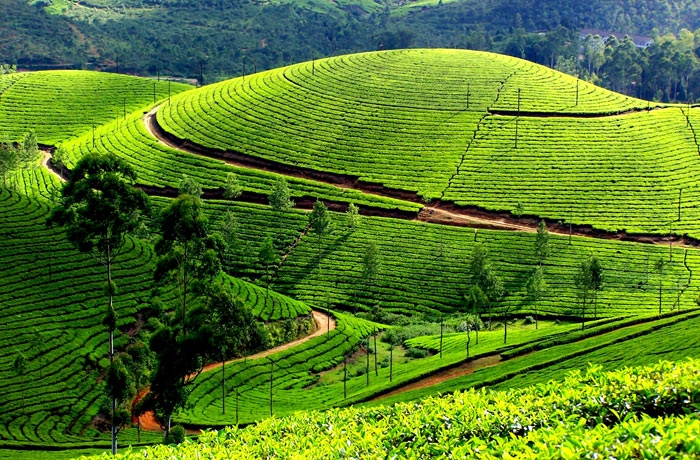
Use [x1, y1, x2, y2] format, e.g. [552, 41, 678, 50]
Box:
[0, 49, 700, 458]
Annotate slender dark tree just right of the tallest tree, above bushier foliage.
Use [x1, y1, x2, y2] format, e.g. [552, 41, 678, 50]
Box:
[154, 194, 223, 335]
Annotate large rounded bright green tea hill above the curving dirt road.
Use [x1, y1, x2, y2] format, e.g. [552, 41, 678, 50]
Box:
[152, 50, 700, 236]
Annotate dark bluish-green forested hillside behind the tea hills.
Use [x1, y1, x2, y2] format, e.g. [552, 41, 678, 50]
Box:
[0, 0, 700, 101]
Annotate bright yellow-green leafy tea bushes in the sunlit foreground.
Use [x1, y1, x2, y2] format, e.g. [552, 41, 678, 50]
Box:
[89, 360, 700, 459]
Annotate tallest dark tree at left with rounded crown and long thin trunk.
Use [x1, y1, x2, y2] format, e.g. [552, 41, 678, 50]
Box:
[47, 153, 149, 453]
